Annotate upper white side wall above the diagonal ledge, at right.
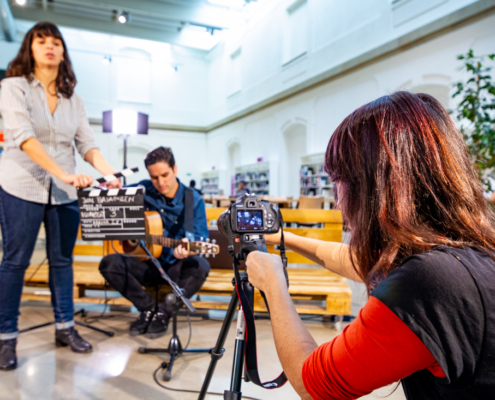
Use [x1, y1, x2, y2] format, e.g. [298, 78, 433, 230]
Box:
[208, 0, 477, 124]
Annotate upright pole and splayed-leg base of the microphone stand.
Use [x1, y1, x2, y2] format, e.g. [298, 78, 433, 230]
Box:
[138, 293, 212, 382]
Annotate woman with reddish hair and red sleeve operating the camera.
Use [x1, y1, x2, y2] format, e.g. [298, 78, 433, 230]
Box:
[246, 92, 495, 400]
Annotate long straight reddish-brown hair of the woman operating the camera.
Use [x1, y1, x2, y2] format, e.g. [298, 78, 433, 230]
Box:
[325, 92, 495, 293]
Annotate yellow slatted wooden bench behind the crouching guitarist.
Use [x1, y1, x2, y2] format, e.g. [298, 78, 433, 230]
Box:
[23, 208, 351, 315]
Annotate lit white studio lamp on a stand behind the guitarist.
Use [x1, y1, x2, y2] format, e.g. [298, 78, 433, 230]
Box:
[102, 110, 148, 185]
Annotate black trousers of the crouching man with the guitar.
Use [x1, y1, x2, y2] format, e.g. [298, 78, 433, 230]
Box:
[100, 254, 210, 317]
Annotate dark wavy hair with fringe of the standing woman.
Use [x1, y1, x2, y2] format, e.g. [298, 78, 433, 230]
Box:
[5, 22, 77, 99]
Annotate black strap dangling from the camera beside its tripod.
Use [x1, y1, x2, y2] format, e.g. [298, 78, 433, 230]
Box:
[228, 210, 289, 389]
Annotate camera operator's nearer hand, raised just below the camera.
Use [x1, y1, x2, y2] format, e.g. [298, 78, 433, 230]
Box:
[246, 251, 287, 293]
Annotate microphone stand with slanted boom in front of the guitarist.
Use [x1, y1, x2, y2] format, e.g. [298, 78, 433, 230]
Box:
[138, 240, 213, 381]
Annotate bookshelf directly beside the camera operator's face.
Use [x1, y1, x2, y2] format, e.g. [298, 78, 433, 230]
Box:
[301, 153, 334, 200]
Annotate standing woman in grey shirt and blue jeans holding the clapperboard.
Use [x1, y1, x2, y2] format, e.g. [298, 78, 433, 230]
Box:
[0, 22, 121, 370]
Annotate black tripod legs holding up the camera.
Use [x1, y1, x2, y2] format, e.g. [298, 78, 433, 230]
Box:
[198, 272, 254, 400]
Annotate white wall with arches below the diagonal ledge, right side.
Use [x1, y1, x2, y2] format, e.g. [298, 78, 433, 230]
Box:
[203, 10, 495, 194]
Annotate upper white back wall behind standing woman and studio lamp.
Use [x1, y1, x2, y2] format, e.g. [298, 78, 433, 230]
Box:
[0, 21, 208, 127]
